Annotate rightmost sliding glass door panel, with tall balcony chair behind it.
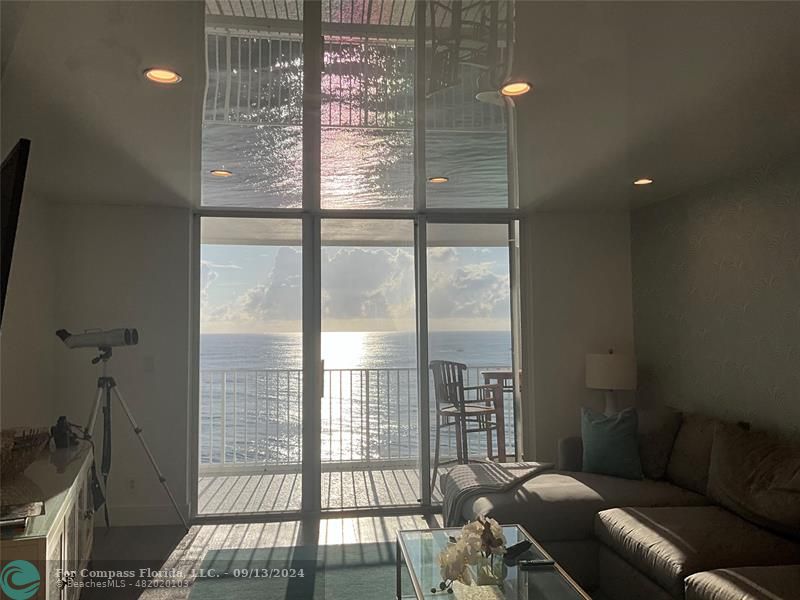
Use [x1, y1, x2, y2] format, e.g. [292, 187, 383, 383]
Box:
[427, 223, 516, 498]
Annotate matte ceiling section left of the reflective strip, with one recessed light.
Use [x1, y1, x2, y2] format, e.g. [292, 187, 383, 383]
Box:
[1, 1, 205, 207]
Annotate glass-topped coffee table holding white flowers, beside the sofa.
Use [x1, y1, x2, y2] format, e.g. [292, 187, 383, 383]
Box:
[396, 525, 591, 600]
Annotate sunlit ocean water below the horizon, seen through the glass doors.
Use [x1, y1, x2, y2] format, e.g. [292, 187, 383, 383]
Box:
[200, 331, 514, 467]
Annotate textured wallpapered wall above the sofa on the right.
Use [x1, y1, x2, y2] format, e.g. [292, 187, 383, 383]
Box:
[631, 156, 800, 434]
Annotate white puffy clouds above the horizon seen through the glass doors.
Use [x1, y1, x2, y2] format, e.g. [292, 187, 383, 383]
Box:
[201, 247, 509, 327]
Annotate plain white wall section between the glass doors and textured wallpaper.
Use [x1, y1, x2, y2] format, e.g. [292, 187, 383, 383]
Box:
[520, 213, 634, 461]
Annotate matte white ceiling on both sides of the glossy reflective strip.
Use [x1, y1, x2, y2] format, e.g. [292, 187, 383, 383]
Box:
[2, 1, 800, 210]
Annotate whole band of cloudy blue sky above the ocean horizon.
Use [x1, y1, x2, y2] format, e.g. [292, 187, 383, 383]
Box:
[200, 244, 510, 333]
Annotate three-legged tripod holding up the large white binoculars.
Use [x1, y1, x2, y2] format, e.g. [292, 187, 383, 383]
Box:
[83, 348, 189, 531]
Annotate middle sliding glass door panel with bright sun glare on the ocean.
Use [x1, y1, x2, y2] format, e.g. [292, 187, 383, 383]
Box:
[320, 219, 420, 509]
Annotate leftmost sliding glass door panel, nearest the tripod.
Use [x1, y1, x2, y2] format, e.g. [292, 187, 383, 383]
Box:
[198, 217, 303, 514]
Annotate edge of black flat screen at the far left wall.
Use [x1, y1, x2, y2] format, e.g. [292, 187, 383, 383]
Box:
[0, 138, 31, 322]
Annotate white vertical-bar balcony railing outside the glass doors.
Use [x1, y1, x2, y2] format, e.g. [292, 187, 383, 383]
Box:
[200, 367, 514, 473]
